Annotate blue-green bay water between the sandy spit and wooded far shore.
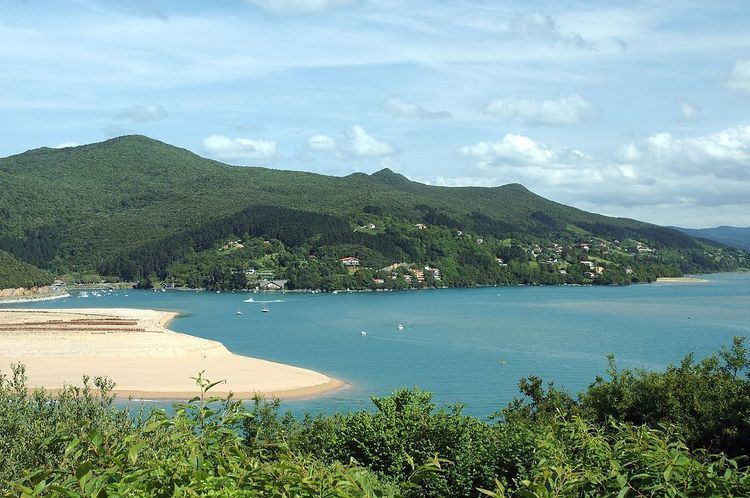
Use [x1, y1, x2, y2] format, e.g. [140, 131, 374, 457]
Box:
[4, 274, 750, 416]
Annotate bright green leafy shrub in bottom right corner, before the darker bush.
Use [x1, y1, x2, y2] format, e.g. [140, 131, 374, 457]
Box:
[482, 417, 750, 498]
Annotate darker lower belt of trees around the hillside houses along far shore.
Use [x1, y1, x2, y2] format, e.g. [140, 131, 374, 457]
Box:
[86, 200, 743, 290]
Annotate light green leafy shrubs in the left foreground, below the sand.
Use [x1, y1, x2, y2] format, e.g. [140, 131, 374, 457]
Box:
[0, 368, 412, 498]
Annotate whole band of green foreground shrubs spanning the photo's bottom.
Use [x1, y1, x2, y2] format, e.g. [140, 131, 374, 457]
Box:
[0, 338, 750, 497]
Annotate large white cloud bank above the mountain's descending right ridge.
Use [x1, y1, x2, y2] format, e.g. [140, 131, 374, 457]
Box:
[456, 125, 750, 216]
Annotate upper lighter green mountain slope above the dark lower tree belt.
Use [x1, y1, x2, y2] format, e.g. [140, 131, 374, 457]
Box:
[0, 136, 742, 284]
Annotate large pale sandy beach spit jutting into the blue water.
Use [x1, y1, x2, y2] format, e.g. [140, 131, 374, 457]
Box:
[0, 308, 344, 399]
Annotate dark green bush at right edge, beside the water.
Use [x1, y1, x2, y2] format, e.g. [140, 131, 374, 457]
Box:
[580, 337, 750, 456]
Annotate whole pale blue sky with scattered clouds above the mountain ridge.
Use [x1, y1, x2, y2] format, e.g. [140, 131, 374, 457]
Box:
[0, 0, 750, 227]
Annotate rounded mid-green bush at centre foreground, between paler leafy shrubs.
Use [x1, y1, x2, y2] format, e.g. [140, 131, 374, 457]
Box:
[245, 389, 533, 497]
